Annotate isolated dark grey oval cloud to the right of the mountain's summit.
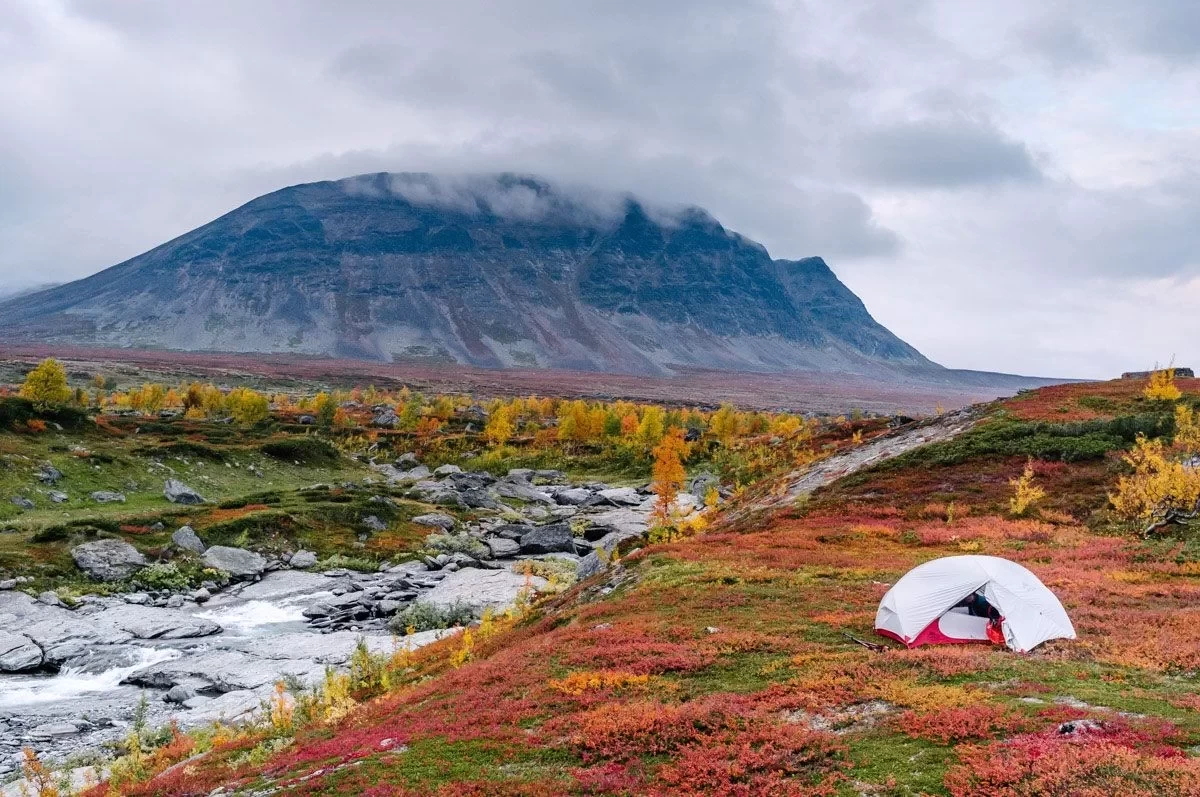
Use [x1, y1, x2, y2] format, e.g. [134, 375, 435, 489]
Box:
[847, 119, 1040, 188]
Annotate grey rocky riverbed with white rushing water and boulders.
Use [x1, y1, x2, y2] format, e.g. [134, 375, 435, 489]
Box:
[0, 457, 710, 778]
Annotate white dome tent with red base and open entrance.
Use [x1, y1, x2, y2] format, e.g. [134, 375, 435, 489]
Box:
[875, 556, 1075, 653]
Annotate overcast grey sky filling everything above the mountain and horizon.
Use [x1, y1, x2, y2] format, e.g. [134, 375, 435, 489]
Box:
[0, 0, 1200, 377]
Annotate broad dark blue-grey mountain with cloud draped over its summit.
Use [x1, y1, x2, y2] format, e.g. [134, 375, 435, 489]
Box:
[0, 174, 940, 373]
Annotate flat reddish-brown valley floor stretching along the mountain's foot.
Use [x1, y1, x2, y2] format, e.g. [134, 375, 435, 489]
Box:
[0, 343, 1068, 414]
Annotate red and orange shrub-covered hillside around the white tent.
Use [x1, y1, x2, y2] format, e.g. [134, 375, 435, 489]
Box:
[75, 374, 1200, 796]
